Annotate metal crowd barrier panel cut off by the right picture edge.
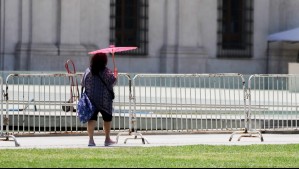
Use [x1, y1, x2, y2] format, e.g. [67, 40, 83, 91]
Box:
[249, 75, 299, 131]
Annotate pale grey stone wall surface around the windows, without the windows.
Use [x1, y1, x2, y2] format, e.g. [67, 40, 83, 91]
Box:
[0, 0, 299, 74]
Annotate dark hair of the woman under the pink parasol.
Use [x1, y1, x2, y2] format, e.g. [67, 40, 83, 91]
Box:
[90, 53, 108, 75]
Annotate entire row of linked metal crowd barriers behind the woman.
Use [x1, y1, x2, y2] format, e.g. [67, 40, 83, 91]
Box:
[0, 74, 299, 145]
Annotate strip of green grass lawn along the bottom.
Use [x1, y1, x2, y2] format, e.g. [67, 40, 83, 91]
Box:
[0, 145, 299, 168]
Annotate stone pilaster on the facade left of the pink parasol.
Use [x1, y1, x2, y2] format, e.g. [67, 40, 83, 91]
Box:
[16, 0, 57, 70]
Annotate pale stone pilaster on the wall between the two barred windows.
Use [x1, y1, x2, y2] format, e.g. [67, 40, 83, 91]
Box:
[161, 0, 207, 73]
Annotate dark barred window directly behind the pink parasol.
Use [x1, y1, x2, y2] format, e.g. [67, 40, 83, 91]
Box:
[110, 0, 148, 55]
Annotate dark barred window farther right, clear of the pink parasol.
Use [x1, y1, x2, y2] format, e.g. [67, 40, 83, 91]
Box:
[217, 0, 253, 58]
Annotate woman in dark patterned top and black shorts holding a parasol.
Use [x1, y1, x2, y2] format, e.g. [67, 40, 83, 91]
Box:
[82, 53, 118, 146]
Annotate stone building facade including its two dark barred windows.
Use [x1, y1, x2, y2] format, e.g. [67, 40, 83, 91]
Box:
[0, 0, 299, 74]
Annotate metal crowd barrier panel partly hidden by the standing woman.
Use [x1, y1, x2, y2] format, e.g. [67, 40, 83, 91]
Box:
[4, 73, 131, 135]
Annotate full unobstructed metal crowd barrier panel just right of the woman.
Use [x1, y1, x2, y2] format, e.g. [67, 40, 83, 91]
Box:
[133, 74, 246, 132]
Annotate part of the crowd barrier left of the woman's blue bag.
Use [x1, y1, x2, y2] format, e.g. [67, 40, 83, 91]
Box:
[4, 74, 83, 134]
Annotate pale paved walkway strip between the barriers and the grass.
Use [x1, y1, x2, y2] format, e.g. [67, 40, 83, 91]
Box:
[0, 134, 299, 149]
